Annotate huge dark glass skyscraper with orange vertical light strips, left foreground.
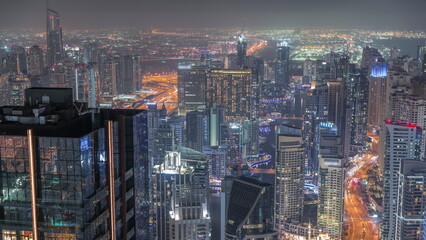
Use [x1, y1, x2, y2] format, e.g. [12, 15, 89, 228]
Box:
[0, 88, 148, 240]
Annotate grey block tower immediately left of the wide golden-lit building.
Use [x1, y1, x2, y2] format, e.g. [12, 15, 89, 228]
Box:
[178, 65, 207, 115]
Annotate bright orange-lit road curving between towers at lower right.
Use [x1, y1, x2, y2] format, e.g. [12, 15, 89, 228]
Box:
[345, 154, 379, 240]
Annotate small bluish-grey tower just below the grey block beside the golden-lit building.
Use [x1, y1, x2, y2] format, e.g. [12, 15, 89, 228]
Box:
[186, 111, 209, 152]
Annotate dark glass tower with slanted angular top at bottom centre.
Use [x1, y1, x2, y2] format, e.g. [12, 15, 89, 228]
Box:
[221, 176, 278, 240]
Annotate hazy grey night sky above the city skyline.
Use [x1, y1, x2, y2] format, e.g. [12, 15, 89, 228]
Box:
[0, 0, 426, 30]
